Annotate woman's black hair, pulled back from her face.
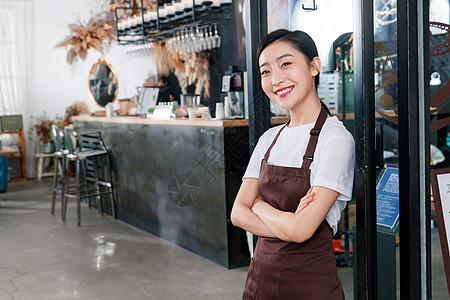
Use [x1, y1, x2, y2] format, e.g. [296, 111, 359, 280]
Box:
[256, 29, 331, 115]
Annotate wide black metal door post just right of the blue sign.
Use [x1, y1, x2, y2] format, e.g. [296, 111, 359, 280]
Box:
[397, 0, 431, 299]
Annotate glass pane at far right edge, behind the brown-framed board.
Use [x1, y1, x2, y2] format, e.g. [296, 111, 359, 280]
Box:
[426, 0, 450, 299]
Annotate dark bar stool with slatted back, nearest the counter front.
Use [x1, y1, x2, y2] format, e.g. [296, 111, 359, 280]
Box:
[63, 126, 115, 226]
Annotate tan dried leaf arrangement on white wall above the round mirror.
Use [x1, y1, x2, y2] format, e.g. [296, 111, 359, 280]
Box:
[55, 1, 118, 65]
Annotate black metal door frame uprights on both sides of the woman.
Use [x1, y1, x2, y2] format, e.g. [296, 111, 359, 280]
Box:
[244, 0, 431, 300]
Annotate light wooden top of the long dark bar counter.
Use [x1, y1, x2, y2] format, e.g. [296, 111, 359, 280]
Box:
[72, 116, 289, 127]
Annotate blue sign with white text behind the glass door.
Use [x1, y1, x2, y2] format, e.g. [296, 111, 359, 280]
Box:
[377, 168, 399, 230]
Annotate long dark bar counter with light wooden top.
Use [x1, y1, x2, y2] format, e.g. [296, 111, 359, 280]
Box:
[73, 116, 253, 268]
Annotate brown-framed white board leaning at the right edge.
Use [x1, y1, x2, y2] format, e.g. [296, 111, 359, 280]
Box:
[431, 168, 450, 296]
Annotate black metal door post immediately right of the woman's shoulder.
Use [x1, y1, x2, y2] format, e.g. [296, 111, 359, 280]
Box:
[353, 0, 378, 300]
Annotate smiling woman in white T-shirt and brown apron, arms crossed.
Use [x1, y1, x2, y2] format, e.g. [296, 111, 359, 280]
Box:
[231, 30, 354, 300]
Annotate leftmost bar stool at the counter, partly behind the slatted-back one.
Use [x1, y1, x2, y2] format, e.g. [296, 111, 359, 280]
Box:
[51, 125, 67, 218]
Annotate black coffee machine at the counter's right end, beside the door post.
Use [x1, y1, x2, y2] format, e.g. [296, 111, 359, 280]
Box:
[222, 66, 245, 119]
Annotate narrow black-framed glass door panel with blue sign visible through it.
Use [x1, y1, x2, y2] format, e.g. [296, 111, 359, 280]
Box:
[354, 0, 431, 299]
